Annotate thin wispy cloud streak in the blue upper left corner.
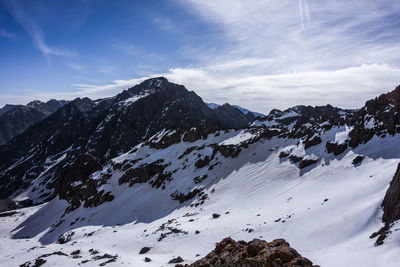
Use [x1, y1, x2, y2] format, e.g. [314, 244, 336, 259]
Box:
[2, 0, 75, 61]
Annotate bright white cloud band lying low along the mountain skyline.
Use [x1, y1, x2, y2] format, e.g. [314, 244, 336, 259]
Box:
[0, 64, 400, 113]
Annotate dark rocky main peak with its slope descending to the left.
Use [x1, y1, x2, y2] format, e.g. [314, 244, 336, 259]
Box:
[0, 78, 253, 202]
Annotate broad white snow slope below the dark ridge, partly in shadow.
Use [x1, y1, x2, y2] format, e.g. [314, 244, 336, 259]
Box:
[0, 129, 400, 267]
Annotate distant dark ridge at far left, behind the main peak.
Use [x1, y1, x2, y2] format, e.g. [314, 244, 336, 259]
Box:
[0, 99, 67, 145]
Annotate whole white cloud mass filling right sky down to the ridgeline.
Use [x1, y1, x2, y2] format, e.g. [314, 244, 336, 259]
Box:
[0, 0, 400, 112]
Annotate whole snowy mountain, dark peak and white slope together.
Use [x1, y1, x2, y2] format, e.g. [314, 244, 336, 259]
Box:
[0, 78, 400, 266]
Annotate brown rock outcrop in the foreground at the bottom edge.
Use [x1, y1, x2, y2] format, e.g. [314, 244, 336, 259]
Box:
[186, 238, 316, 267]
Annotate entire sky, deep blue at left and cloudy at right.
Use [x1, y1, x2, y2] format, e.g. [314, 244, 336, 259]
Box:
[0, 0, 400, 113]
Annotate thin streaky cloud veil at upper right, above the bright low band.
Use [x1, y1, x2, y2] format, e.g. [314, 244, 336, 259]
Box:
[181, 0, 400, 70]
